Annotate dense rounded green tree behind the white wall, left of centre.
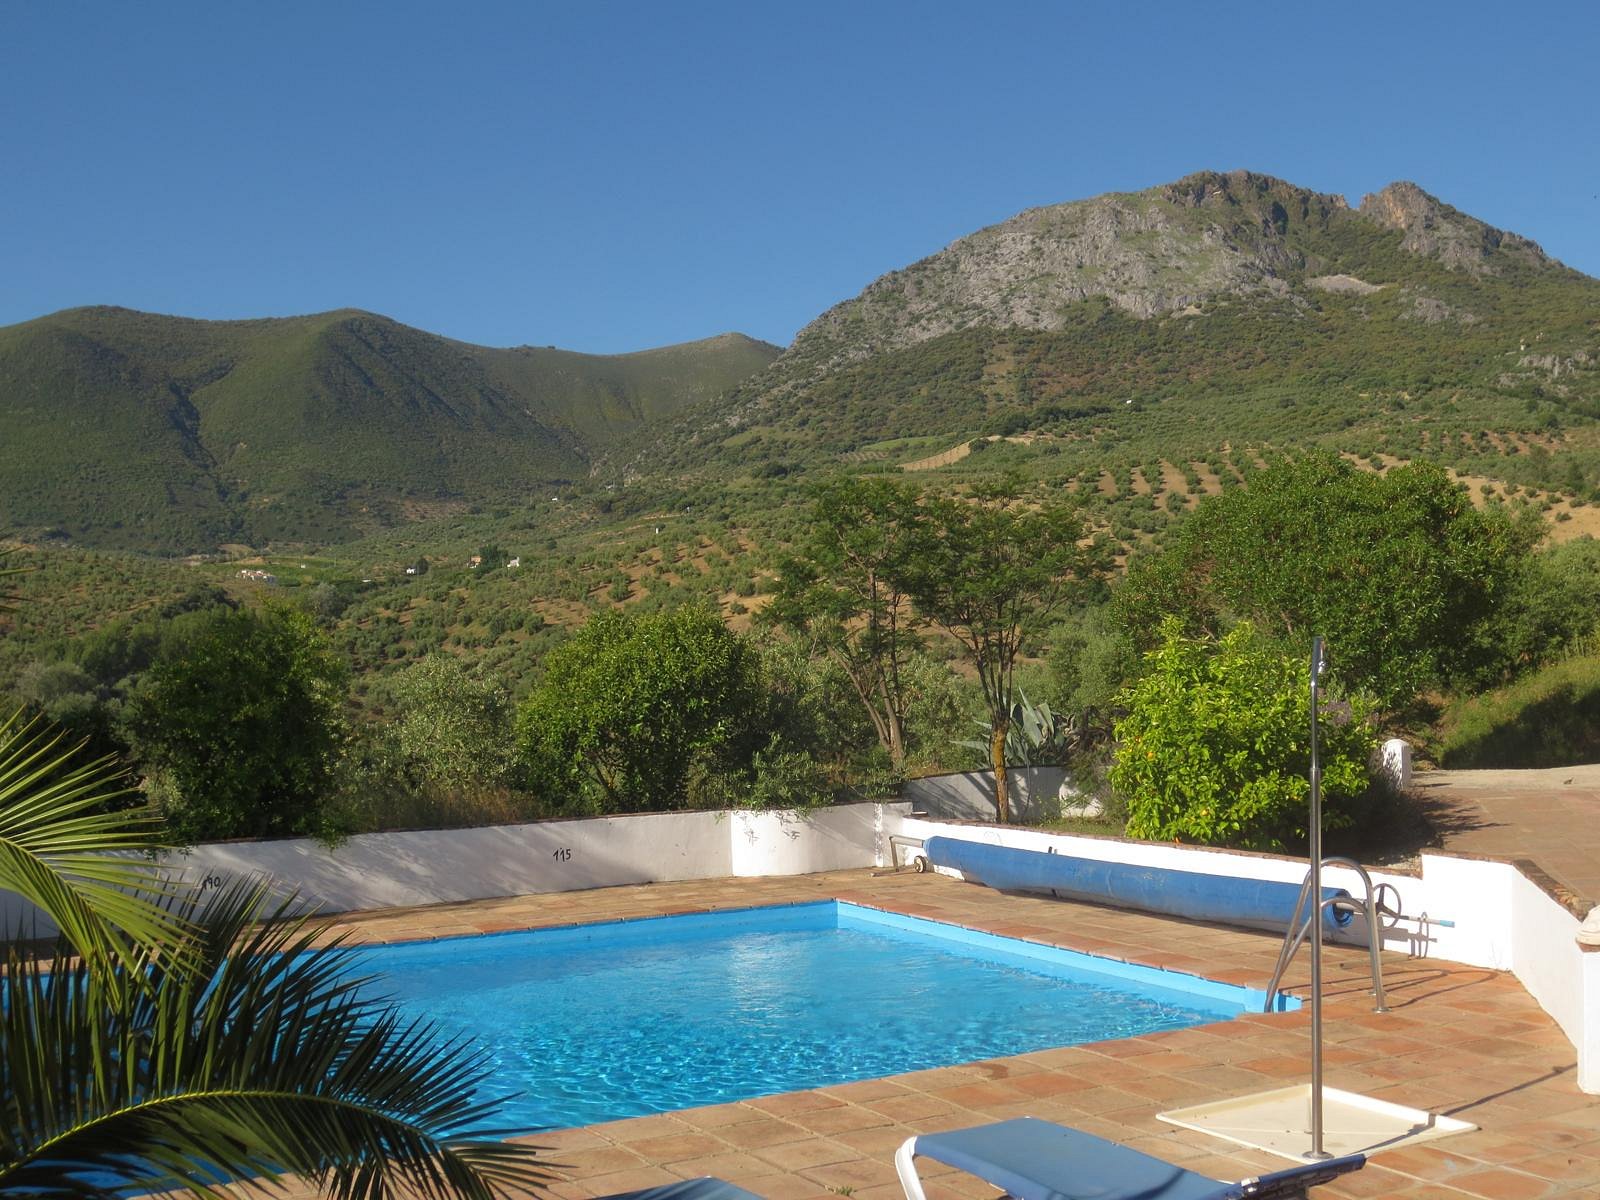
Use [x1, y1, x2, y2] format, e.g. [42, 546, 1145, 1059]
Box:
[517, 608, 768, 813]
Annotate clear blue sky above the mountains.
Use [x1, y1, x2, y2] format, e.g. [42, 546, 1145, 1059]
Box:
[0, 0, 1600, 352]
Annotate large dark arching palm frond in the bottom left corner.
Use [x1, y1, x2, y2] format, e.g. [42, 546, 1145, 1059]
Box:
[0, 886, 544, 1200]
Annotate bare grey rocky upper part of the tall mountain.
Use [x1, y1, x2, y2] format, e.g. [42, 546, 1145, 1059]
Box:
[790, 171, 1550, 370]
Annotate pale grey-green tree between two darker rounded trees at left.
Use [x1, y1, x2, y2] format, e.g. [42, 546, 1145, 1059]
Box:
[390, 654, 517, 789]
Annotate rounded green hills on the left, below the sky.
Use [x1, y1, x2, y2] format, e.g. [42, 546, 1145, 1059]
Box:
[0, 309, 776, 552]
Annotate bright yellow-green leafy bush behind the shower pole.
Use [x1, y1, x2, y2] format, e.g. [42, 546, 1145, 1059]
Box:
[1110, 619, 1374, 850]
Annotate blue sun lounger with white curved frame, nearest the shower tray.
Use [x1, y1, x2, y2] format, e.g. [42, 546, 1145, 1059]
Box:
[894, 1117, 1366, 1200]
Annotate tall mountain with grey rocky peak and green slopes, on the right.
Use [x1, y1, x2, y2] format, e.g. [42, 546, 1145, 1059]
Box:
[630, 171, 1600, 492]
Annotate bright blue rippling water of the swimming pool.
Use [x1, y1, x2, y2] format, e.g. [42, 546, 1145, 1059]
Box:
[360, 901, 1261, 1130]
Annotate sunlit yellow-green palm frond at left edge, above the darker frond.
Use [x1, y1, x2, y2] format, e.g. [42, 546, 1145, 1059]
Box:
[0, 712, 179, 955]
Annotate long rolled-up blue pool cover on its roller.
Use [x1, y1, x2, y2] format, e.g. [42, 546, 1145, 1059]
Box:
[922, 837, 1352, 933]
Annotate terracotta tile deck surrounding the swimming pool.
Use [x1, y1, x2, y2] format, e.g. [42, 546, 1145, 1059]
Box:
[308, 870, 1600, 1200]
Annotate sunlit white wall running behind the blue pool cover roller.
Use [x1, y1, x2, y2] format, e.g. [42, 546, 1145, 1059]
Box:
[885, 813, 1600, 1093]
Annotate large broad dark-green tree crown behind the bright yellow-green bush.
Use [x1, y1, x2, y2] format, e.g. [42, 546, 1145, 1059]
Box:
[1115, 451, 1538, 709]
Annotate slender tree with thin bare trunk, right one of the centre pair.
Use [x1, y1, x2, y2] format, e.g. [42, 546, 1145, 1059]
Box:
[902, 485, 1102, 821]
